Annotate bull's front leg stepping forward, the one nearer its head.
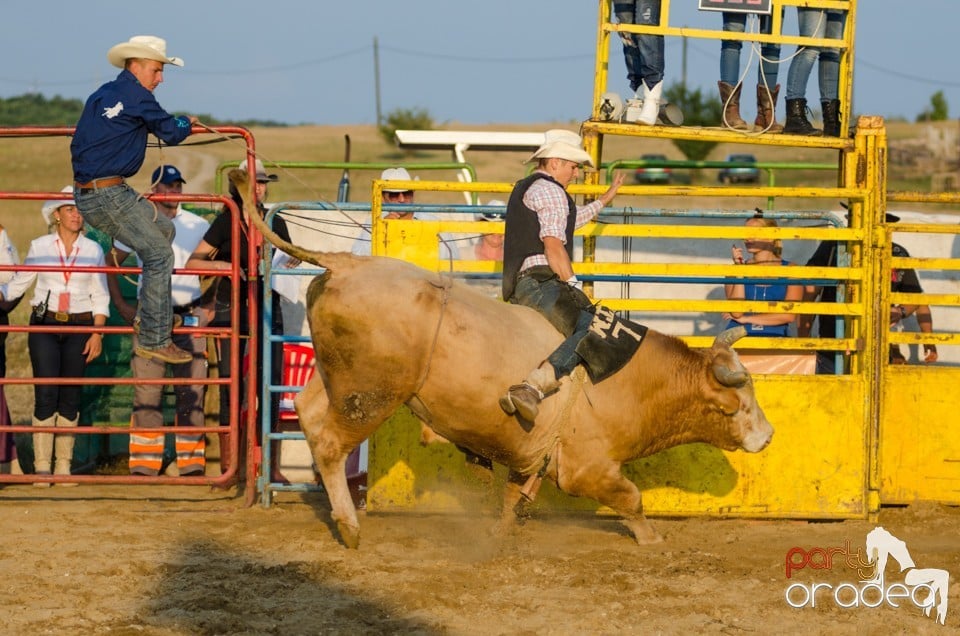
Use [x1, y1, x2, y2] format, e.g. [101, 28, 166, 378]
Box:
[558, 463, 663, 545]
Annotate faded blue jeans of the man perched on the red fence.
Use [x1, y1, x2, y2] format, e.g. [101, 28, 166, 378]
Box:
[74, 184, 176, 349]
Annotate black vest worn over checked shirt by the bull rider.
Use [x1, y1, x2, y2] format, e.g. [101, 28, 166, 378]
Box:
[503, 172, 577, 300]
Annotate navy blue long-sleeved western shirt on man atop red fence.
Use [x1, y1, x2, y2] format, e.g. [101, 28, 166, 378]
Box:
[70, 70, 190, 183]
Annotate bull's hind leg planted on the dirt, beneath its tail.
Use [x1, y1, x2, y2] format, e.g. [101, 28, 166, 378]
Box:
[294, 374, 366, 548]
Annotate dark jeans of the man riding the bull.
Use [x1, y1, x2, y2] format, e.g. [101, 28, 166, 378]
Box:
[510, 275, 593, 379]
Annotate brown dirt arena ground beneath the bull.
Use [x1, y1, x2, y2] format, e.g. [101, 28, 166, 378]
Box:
[0, 485, 960, 635]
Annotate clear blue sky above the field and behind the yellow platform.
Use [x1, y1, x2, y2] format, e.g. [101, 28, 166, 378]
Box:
[0, 0, 960, 124]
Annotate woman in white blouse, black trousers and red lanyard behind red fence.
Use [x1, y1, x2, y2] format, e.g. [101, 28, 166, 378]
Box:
[0, 186, 110, 487]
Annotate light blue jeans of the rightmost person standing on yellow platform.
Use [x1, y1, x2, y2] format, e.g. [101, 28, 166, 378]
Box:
[787, 7, 846, 100]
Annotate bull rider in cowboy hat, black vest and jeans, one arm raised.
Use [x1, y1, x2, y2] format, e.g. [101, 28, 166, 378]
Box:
[500, 130, 623, 422]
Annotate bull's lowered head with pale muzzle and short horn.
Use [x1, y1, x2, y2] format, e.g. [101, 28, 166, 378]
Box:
[711, 326, 773, 453]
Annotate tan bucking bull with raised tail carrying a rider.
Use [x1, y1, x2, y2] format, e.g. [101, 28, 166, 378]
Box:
[230, 171, 773, 547]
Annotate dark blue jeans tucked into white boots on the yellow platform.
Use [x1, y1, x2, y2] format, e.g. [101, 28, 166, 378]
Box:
[613, 0, 663, 92]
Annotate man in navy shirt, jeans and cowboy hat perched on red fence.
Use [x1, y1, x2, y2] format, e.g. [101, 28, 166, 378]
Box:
[70, 35, 197, 364]
